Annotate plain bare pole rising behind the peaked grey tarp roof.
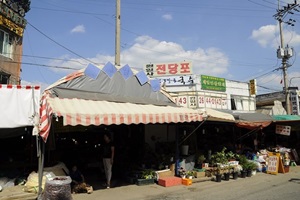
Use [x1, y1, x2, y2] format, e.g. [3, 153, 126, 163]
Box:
[115, 0, 121, 66]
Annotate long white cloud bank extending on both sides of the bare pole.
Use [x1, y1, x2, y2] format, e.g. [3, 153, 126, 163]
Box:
[40, 36, 229, 89]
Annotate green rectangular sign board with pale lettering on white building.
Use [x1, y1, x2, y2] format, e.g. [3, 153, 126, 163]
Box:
[201, 75, 226, 92]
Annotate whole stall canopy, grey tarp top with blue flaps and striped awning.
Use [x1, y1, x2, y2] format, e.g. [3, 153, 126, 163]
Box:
[40, 63, 202, 141]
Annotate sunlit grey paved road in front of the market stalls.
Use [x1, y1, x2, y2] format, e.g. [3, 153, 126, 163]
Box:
[73, 166, 300, 200]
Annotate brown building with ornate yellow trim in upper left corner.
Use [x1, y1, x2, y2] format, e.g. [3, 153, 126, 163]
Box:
[0, 0, 30, 85]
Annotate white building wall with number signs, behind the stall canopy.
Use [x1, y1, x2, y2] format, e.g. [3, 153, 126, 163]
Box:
[162, 75, 256, 111]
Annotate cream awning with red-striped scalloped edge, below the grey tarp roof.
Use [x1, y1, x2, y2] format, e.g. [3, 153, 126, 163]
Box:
[40, 96, 202, 141]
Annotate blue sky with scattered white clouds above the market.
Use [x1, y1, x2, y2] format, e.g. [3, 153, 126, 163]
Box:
[21, 0, 300, 93]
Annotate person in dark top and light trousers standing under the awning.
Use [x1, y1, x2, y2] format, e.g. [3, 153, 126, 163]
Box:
[103, 132, 115, 188]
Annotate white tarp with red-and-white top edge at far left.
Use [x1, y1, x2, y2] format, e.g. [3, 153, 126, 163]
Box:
[0, 85, 41, 128]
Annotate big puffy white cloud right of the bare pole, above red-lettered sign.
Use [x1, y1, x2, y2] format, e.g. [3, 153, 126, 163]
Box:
[121, 36, 228, 76]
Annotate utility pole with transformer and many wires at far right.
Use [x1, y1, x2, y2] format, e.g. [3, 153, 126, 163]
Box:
[273, 0, 299, 115]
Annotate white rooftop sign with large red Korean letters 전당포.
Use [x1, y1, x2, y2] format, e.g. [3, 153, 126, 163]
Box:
[145, 62, 192, 77]
